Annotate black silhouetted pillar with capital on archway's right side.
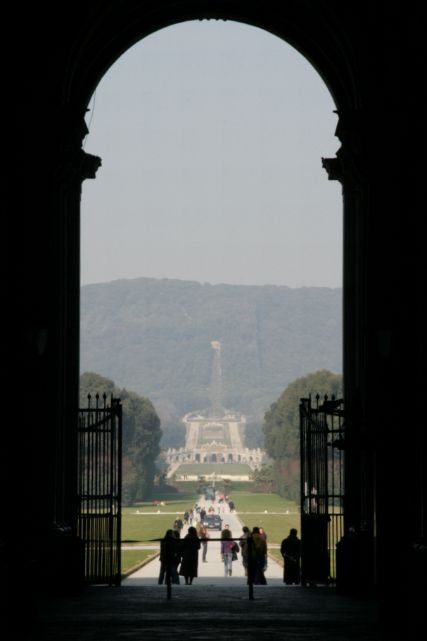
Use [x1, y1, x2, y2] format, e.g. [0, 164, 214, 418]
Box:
[322, 110, 374, 592]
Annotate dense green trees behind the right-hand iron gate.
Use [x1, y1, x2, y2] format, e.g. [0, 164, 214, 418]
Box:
[263, 370, 342, 499]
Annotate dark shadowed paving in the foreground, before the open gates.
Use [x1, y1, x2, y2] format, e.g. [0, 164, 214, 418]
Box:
[27, 583, 378, 641]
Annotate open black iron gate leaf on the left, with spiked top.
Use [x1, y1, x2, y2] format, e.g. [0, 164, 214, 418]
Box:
[77, 394, 122, 585]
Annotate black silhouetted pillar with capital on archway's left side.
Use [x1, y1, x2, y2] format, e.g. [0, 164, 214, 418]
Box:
[46, 107, 101, 585]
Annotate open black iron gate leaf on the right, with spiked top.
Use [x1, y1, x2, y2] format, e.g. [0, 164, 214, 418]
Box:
[300, 396, 344, 583]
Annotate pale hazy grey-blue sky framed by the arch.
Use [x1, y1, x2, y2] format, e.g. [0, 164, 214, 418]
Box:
[81, 21, 342, 287]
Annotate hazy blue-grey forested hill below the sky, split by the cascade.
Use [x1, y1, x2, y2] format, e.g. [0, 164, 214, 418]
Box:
[81, 278, 342, 438]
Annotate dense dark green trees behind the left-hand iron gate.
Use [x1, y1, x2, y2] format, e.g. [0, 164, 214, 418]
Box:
[80, 372, 162, 503]
